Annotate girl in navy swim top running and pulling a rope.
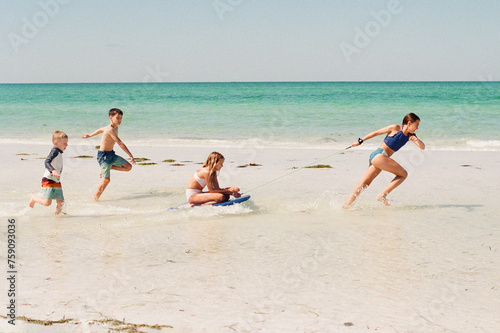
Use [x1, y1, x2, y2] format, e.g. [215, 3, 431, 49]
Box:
[344, 113, 425, 208]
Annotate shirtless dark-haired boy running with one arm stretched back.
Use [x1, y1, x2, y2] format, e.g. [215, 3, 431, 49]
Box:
[82, 109, 135, 201]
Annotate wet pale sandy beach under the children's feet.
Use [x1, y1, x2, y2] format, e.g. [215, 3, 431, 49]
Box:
[0, 141, 500, 332]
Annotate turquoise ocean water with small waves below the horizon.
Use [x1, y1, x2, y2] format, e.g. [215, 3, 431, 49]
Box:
[0, 82, 500, 150]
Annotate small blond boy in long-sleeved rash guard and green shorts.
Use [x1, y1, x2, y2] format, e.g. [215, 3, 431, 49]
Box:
[29, 131, 68, 215]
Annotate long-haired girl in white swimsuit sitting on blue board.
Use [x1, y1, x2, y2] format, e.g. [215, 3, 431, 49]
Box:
[186, 152, 241, 205]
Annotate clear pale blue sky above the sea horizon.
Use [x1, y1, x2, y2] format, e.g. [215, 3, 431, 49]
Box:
[0, 0, 500, 83]
